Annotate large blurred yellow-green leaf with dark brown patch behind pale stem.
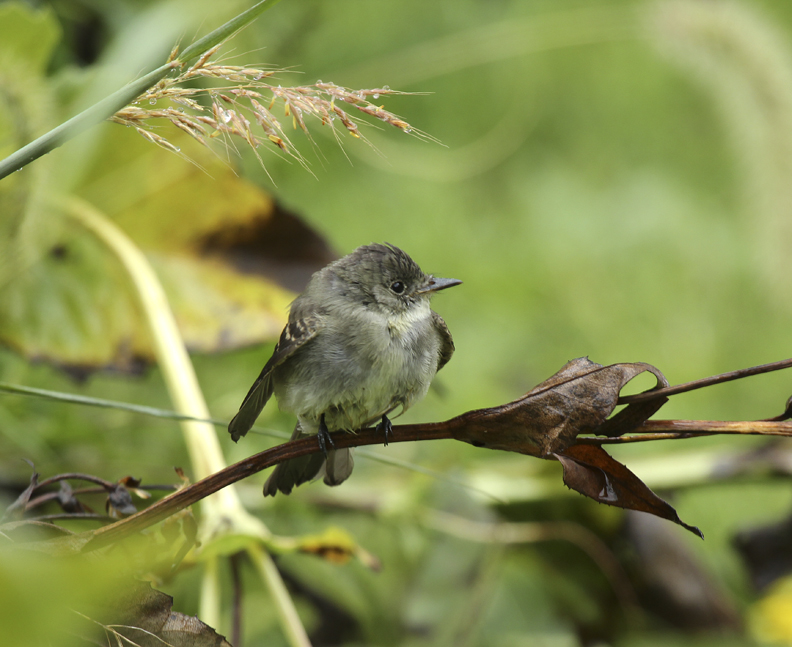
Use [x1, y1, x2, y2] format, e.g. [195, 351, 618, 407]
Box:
[0, 82, 333, 373]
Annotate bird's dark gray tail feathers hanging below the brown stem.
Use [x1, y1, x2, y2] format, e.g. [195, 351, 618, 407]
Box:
[264, 424, 355, 496]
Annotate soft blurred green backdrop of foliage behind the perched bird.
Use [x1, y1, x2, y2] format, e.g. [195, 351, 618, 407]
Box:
[0, 0, 792, 646]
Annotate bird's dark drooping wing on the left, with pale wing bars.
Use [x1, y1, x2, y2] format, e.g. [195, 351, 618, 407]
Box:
[228, 316, 322, 442]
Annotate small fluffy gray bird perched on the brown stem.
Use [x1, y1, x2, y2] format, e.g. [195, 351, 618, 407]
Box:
[228, 244, 462, 496]
